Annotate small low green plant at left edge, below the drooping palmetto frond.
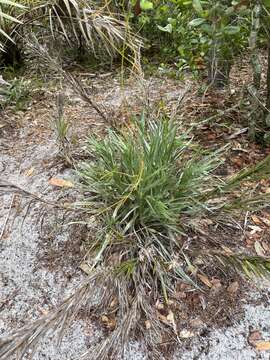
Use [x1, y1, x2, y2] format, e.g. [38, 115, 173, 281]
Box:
[0, 78, 30, 110]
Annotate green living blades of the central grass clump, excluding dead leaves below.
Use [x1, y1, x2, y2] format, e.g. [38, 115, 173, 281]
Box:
[80, 117, 221, 234]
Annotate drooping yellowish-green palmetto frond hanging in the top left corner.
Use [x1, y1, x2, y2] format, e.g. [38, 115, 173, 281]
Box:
[0, 0, 142, 63]
